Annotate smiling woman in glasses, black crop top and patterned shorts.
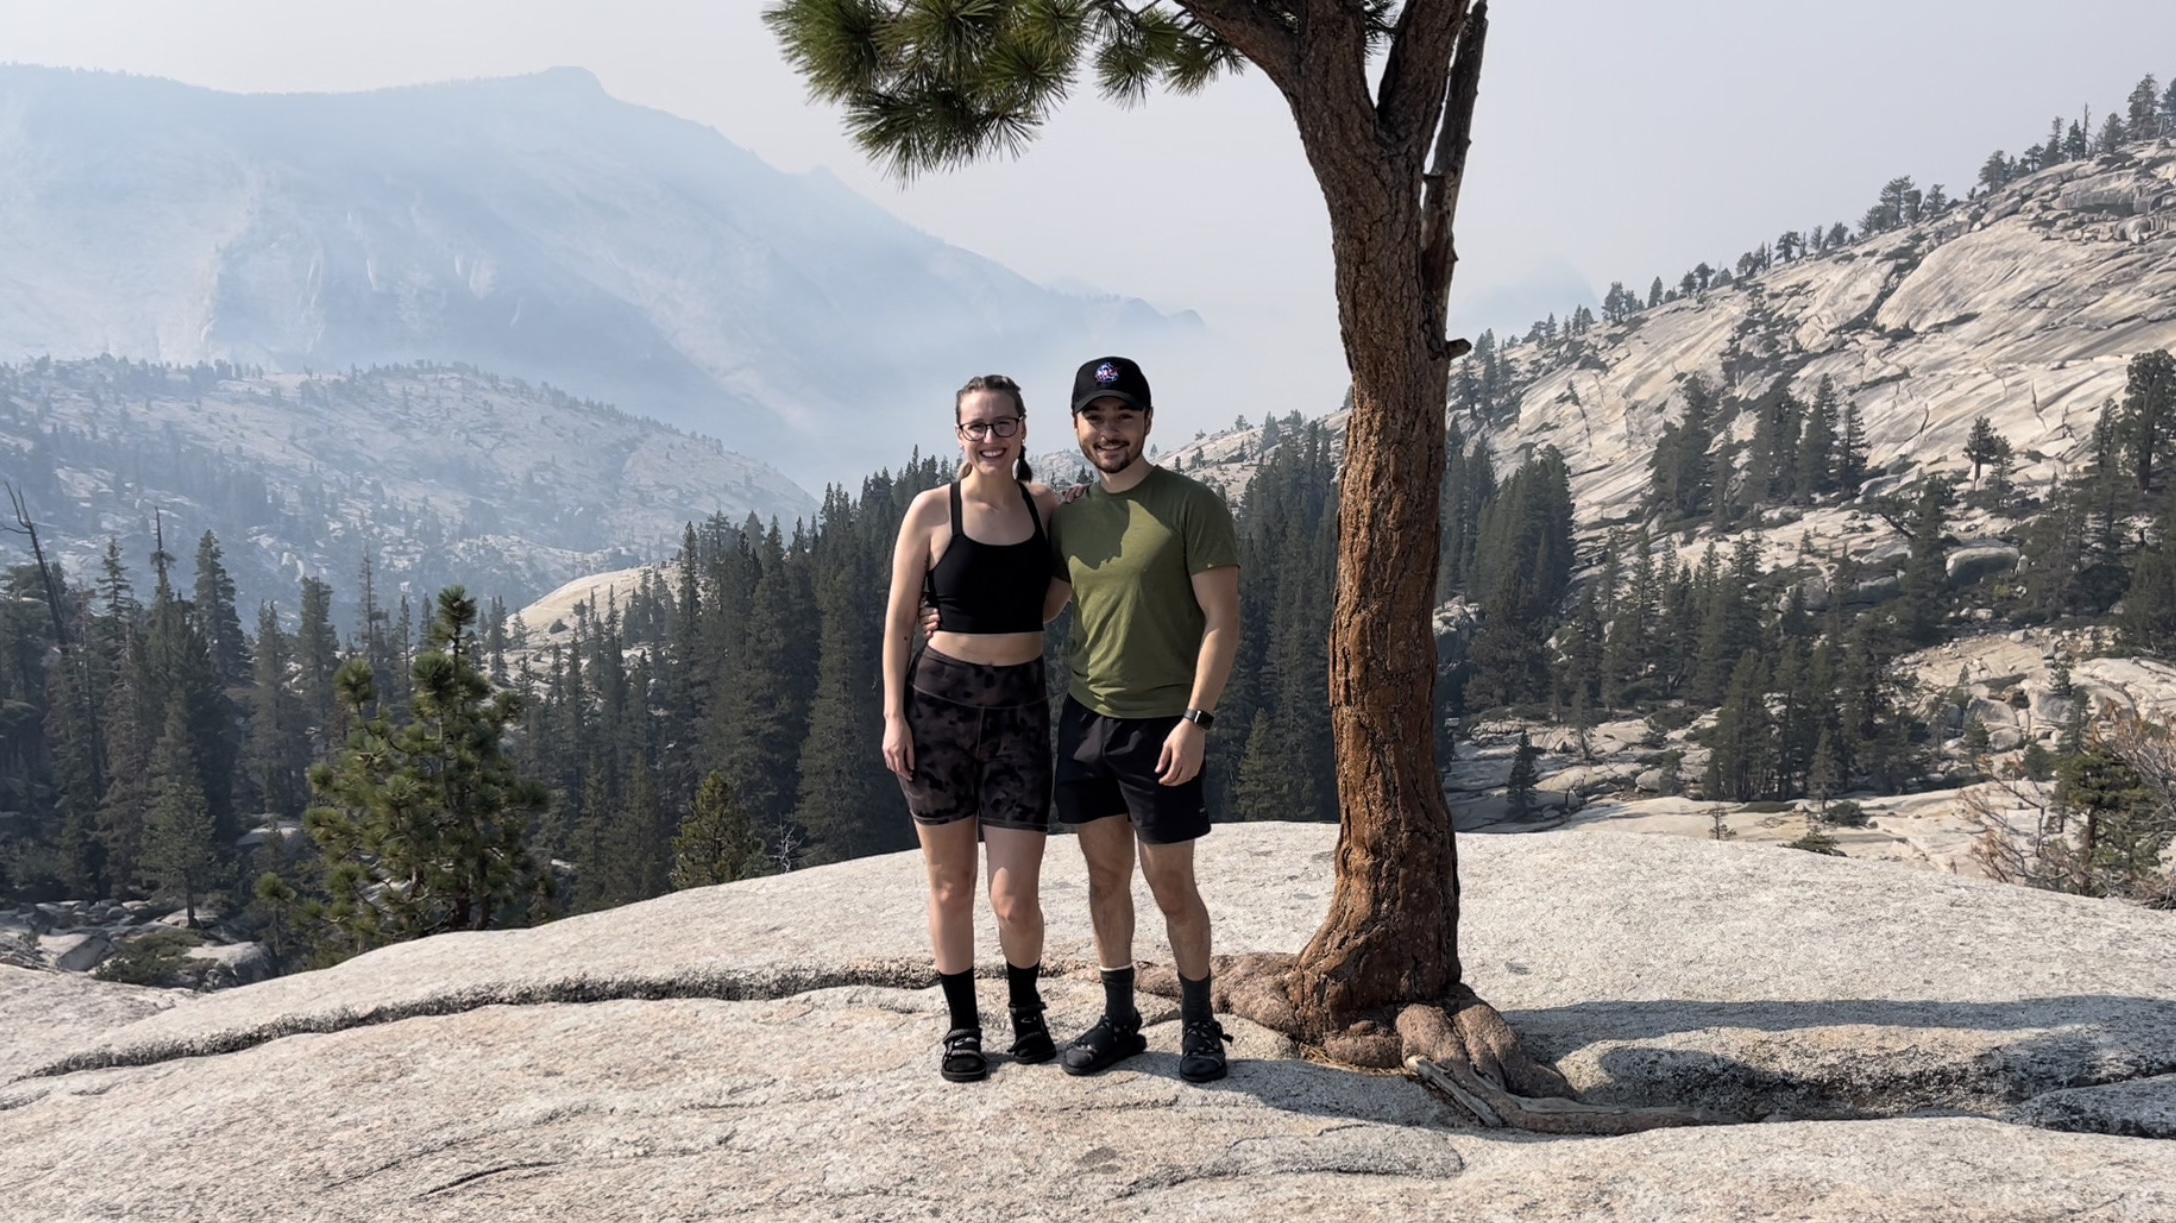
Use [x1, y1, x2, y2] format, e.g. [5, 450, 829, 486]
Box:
[883, 374, 1058, 1082]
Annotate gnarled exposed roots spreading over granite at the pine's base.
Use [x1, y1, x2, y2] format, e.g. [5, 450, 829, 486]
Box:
[1140, 953, 1732, 1134]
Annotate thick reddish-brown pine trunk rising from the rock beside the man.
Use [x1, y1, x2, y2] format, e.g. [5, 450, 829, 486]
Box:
[1288, 104, 1460, 1040]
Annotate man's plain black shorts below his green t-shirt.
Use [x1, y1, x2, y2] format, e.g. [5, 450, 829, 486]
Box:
[1058, 696, 1210, 844]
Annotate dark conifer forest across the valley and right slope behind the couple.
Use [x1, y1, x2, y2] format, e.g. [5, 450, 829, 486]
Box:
[0, 78, 2176, 971]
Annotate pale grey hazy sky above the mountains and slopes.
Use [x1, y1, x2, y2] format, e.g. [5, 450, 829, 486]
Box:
[0, 0, 2176, 420]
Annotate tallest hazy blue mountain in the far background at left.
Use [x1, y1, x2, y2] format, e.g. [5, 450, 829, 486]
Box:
[0, 65, 1195, 487]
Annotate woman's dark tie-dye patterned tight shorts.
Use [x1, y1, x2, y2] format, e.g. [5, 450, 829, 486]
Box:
[899, 648, 1051, 831]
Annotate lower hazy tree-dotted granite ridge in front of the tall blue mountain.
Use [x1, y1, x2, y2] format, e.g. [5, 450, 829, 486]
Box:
[0, 357, 816, 622]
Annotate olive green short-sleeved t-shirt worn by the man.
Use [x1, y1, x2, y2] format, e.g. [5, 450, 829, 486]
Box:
[1051, 468, 1238, 718]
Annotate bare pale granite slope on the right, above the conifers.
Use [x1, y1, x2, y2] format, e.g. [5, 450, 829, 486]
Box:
[1482, 141, 2176, 524]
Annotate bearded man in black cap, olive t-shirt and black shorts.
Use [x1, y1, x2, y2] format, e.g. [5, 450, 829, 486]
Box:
[1051, 357, 1238, 1084]
